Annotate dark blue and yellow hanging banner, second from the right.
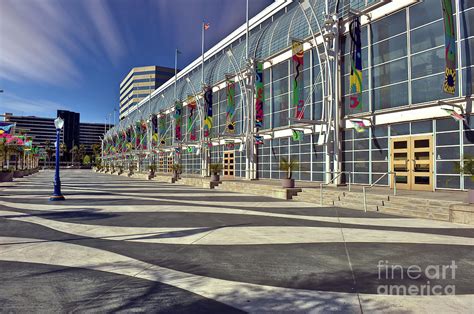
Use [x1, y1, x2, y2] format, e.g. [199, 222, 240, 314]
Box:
[349, 17, 362, 109]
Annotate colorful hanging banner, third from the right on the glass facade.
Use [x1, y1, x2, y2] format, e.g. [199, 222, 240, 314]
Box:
[291, 40, 304, 119]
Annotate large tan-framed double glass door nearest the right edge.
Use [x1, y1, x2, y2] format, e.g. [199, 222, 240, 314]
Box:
[390, 136, 434, 191]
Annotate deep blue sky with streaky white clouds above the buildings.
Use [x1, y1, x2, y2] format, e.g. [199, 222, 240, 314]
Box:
[0, 0, 273, 123]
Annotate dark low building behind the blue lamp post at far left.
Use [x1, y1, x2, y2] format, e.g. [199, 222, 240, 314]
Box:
[4, 110, 112, 157]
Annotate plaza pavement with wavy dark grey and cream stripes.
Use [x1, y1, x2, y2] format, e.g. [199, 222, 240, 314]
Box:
[0, 170, 474, 313]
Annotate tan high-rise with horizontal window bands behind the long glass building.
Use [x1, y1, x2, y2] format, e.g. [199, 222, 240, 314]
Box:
[119, 66, 174, 119]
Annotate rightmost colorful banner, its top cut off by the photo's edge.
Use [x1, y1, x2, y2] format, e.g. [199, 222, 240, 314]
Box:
[442, 0, 456, 95]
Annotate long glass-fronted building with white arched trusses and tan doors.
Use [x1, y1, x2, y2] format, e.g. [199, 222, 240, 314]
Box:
[106, 0, 474, 191]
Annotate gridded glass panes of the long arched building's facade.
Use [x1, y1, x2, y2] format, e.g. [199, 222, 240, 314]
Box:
[107, 0, 474, 189]
